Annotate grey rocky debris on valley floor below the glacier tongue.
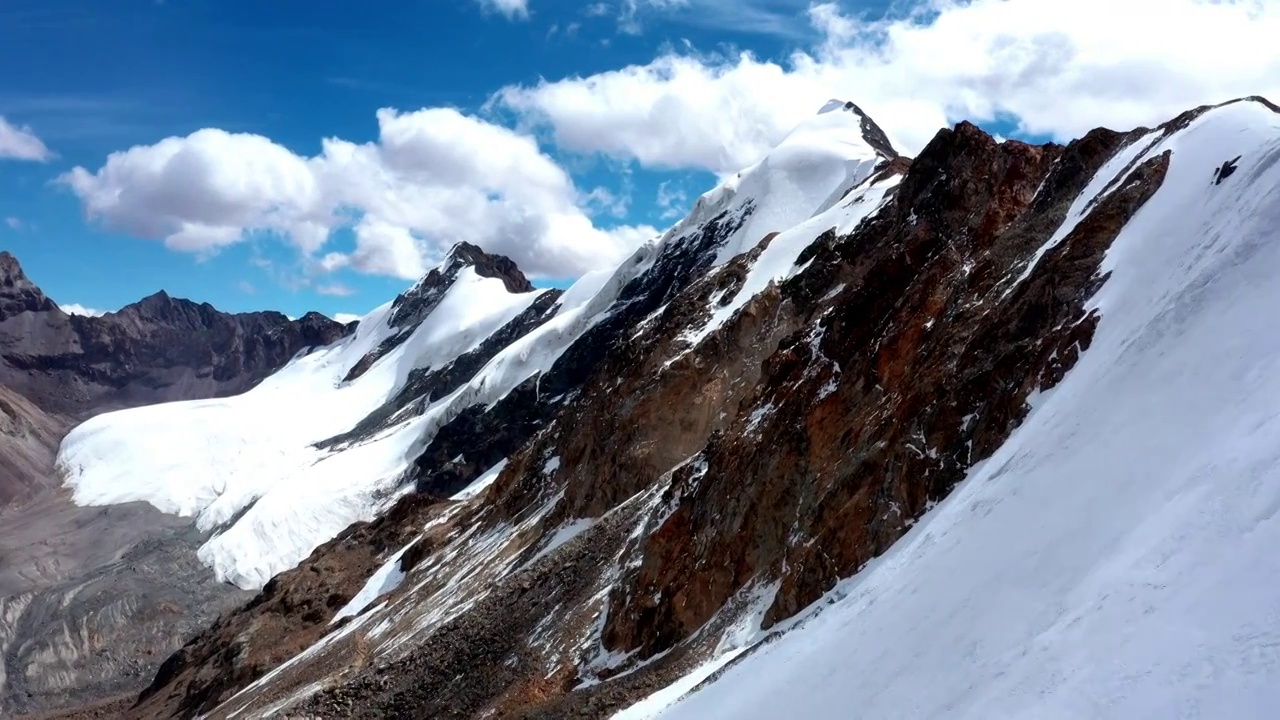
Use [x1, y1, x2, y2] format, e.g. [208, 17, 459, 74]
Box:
[0, 493, 243, 716]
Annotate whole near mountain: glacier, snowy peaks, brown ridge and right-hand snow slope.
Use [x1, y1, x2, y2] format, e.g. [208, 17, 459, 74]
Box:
[20, 99, 1280, 720]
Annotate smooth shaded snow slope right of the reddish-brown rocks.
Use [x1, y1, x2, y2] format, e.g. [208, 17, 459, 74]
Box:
[648, 101, 1280, 720]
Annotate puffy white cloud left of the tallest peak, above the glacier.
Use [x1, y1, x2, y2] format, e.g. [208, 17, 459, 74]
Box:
[60, 108, 655, 279]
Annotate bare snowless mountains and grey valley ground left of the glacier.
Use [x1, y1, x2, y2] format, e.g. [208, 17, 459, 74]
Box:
[0, 252, 348, 715]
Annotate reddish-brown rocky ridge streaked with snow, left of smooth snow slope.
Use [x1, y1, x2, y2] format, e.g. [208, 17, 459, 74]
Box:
[42, 99, 1280, 717]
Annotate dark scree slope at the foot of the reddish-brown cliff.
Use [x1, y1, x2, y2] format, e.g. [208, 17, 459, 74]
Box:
[277, 491, 682, 719]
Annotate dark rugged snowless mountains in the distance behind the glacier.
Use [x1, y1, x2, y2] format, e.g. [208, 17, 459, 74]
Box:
[0, 251, 346, 505]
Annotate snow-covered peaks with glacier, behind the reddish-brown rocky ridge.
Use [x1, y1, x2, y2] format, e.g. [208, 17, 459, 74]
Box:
[58, 101, 896, 588]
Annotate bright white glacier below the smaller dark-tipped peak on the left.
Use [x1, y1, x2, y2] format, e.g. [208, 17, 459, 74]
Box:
[59, 268, 538, 588]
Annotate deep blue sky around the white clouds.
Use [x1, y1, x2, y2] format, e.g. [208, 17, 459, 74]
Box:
[0, 0, 860, 315]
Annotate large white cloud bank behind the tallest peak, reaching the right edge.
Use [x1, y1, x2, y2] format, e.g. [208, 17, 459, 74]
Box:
[493, 0, 1280, 174]
